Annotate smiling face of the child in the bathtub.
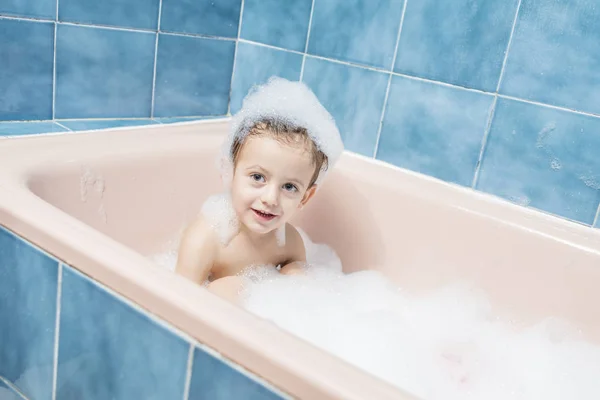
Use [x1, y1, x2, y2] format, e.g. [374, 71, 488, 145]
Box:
[231, 135, 316, 234]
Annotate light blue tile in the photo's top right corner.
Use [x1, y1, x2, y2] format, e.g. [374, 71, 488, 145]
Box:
[500, 0, 600, 113]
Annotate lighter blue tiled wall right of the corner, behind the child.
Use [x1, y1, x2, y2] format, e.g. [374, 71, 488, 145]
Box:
[231, 0, 600, 227]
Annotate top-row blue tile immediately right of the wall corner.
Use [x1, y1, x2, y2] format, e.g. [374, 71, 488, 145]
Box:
[240, 0, 312, 52]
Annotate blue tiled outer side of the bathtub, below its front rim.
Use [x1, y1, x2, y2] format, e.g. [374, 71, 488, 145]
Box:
[0, 227, 287, 400]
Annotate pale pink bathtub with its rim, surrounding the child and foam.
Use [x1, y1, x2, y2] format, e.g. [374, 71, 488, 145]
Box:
[0, 119, 600, 400]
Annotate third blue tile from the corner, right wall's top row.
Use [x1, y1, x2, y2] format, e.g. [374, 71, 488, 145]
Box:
[394, 0, 518, 92]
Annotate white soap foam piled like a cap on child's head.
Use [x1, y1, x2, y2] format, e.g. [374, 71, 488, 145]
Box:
[219, 77, 344, 185]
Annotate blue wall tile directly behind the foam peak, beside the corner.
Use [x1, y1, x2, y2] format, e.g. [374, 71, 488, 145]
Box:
[231, 42, 302, 114]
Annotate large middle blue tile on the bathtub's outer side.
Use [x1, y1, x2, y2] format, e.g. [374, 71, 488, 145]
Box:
[56, 267, 190, 400]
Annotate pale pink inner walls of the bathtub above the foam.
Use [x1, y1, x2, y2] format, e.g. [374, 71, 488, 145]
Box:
[21, 122, 600, 343]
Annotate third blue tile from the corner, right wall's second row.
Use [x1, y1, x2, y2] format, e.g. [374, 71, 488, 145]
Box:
[377, 76, 493, 186]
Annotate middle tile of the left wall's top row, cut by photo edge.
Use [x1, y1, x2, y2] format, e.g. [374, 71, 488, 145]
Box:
[58, 0, 159, 30]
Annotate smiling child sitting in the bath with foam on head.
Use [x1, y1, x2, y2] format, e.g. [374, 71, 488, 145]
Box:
[176, 78, 343, 301]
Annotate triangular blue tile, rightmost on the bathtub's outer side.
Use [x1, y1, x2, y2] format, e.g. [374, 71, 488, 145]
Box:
[189, 348, 283, 400]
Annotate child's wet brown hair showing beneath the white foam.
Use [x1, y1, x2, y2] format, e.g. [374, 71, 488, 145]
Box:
[231, 118, 328, 188]
